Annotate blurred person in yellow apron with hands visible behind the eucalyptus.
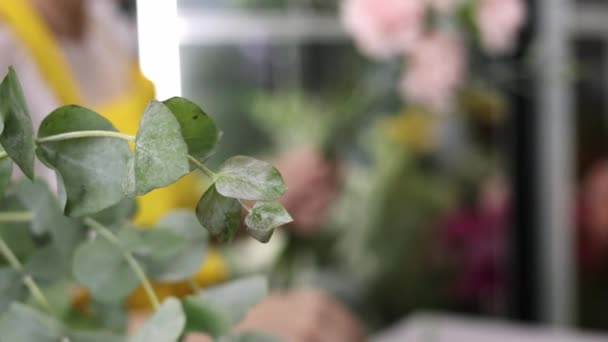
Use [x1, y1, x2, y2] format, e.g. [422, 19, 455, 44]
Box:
[0, 0, 361, 342]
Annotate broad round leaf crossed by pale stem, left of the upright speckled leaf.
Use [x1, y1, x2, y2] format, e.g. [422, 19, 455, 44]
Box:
[37, 105, 131, 216]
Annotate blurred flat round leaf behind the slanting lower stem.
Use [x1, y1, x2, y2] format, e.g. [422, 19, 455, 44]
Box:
[73, 238, 139, 302]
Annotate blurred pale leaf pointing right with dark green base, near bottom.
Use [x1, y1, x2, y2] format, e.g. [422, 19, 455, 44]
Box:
[183, 276, 268, 337]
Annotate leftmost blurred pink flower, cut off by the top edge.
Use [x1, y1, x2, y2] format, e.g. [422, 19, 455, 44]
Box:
[341, 0, 426, 58]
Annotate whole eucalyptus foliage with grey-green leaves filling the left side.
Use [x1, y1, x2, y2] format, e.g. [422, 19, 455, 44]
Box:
[0, 68, 291, 342]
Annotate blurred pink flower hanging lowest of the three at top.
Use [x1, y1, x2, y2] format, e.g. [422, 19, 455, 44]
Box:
[400, 33, 466, 112]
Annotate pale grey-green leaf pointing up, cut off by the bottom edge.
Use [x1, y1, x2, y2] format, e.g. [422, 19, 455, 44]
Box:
[130, 298, 186, 342]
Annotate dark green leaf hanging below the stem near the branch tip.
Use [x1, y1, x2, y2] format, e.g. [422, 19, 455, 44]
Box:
[196, 185, 241, 242]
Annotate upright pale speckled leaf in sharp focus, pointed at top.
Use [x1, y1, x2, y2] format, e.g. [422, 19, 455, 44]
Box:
[125, 101, 190, 195]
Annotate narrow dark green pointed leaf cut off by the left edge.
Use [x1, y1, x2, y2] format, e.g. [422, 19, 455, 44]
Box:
[0, 67, 36, 179]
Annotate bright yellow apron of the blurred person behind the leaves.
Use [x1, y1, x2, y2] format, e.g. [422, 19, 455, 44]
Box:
[0, 0, 226, 308]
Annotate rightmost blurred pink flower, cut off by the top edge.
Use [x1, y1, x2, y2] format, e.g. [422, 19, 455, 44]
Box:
[477, 0, 527, 54]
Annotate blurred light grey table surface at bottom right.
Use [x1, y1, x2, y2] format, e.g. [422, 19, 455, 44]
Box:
[372, 313, 608, 342]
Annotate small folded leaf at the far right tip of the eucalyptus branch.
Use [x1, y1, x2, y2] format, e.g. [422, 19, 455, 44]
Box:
[245, 202, 293, 243]
